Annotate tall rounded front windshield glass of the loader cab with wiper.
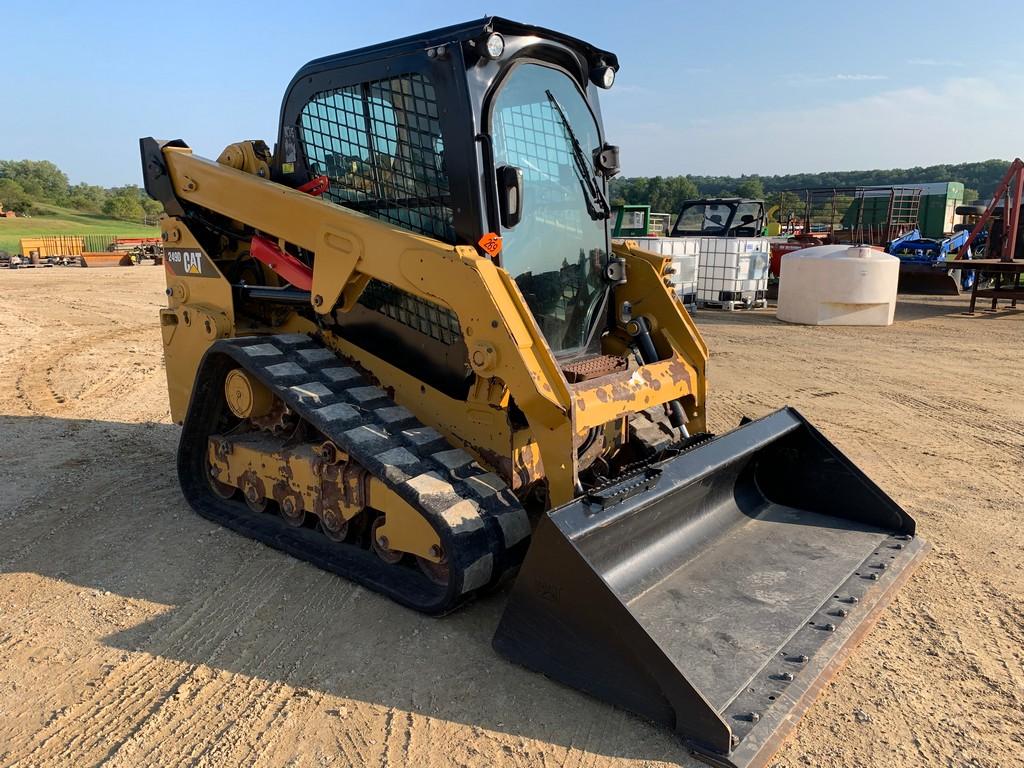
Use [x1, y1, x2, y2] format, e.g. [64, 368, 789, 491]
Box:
[492, 63, 607, 354]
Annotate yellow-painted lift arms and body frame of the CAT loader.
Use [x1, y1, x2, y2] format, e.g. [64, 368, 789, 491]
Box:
[162, 146, 708, 514]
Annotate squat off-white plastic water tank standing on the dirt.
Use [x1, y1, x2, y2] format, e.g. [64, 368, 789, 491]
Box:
[775, 245, 899, 326]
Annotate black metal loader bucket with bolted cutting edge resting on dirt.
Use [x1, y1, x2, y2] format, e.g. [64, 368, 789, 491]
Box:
[494, 409, 926, 768]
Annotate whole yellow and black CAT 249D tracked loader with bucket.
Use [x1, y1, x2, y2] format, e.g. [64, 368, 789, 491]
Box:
[140, 18, 924, 766]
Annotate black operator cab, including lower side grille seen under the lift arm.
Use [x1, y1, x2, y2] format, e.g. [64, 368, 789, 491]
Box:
[272, 17, 618, 390]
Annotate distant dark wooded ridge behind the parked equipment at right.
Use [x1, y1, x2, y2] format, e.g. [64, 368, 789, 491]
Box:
[609, 160, 1010, 213]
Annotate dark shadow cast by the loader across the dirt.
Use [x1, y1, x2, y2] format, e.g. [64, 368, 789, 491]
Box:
[0, 416, 697, 765]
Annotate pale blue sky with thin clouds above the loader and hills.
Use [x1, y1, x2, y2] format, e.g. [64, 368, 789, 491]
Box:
[0, 0, 1024, 186]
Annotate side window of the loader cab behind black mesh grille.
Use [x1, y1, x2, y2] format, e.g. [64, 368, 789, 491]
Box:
[299, 74, 455, 243]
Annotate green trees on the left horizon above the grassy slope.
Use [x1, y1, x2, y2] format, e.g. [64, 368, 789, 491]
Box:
[0, 160, 164, 223]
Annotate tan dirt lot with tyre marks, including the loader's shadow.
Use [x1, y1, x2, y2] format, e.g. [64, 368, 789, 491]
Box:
[0, 267, 1024, 768]
